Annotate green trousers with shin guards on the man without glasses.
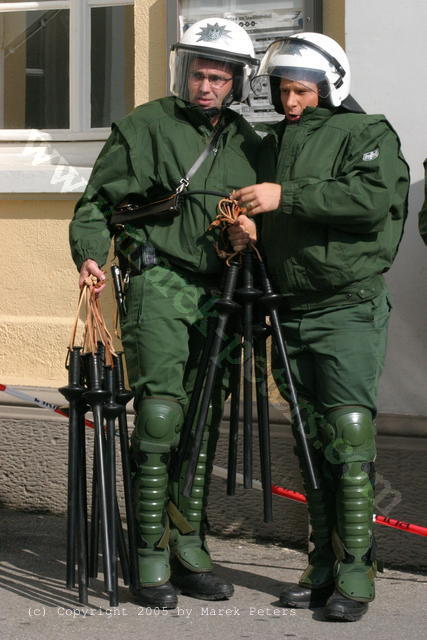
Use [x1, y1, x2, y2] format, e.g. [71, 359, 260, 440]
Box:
[272, 292, 390, 601]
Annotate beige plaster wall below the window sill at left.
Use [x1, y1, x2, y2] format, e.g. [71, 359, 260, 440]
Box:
[0, 200, 118, 387]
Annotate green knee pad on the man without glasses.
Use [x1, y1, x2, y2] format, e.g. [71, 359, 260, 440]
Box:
[322, 406, 376, 465]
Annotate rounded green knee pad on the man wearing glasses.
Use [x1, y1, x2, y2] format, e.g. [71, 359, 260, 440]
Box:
[132, 398, 184, 453]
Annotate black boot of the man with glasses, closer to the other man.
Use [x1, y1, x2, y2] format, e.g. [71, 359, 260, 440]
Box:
[171, 559, 234, 600]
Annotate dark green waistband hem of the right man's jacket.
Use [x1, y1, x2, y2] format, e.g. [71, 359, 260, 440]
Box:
[281, 275, 386, 311]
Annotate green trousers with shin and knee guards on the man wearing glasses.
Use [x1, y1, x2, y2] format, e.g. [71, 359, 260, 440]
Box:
[122, 265, 232, 586]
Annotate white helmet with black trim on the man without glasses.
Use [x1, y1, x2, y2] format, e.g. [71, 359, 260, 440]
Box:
[252, 32, 350, 113]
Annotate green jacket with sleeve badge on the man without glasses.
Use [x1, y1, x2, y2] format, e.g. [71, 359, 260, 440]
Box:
[258, 107, 409, 308]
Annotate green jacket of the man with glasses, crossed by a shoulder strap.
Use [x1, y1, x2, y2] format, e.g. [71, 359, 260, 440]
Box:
[70, 97, 260, 273]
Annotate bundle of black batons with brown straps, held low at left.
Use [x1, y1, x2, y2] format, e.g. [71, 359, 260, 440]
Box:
[59, 274, 138, 606]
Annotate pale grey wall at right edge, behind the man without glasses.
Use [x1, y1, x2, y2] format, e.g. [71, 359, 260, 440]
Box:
[345, 0, 427, 416]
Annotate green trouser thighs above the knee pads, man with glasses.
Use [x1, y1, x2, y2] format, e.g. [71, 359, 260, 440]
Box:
[122, 265, 231, 409]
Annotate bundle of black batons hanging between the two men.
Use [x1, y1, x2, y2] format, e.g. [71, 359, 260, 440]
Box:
[177, 249, 318, 522]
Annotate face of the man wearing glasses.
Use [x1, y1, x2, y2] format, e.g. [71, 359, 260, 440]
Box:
[188, 58, 233, 109]
